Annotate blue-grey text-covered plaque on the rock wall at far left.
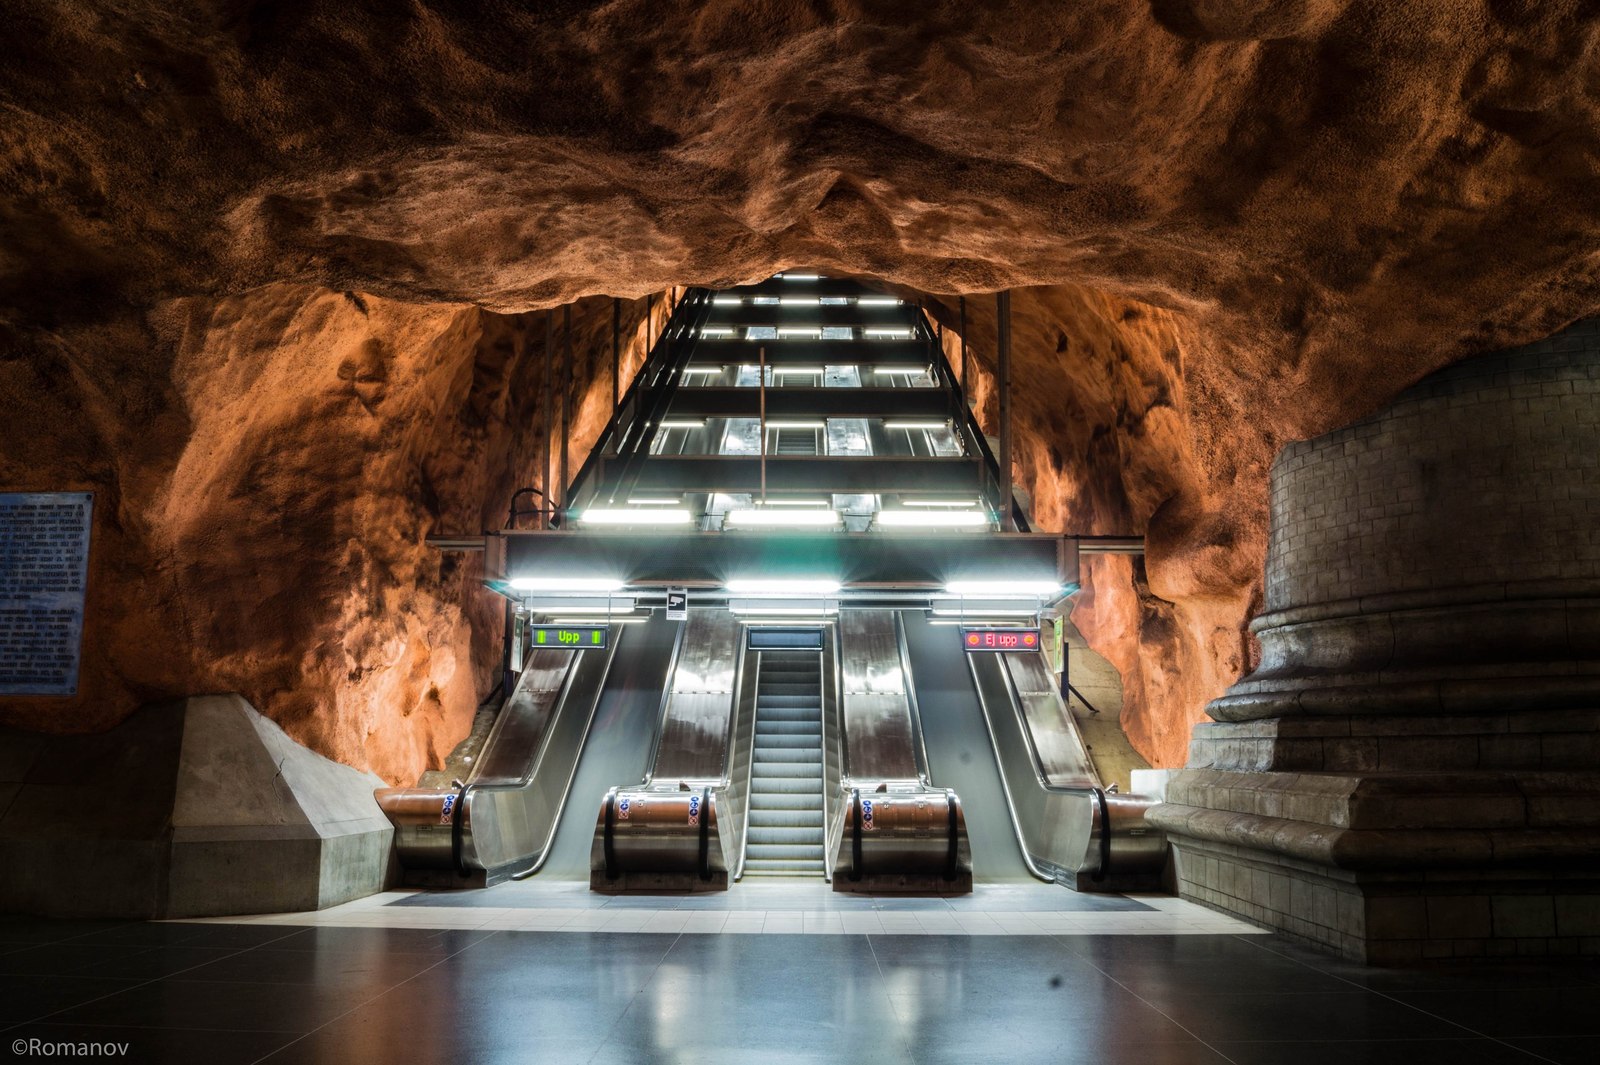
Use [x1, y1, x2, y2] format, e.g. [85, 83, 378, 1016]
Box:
[0, 493, 94, 696]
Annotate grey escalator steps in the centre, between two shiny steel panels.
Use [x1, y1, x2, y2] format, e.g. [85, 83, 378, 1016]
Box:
[744, 651, 824, 876]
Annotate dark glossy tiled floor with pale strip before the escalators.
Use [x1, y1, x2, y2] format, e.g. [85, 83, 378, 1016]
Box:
[0, 889, 1600, 1065]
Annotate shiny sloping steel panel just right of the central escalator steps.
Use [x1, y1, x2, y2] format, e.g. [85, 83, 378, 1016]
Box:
[838, 609, 926, 784]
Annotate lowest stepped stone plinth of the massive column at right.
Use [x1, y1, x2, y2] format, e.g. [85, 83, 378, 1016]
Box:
[1150, 757, 1600, 964]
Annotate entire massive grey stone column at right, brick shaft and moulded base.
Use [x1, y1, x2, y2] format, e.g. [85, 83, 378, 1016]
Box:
[1152, 320, 1600, 963]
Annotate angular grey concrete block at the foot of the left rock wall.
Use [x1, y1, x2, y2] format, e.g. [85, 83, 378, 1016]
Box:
[0, 696, 394, 918]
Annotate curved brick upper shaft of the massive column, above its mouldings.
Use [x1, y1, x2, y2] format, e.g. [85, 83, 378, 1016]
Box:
[1266, 320, 1600, 611]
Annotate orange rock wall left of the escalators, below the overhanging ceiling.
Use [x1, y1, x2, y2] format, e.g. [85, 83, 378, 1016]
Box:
[0, 285, 666, 782]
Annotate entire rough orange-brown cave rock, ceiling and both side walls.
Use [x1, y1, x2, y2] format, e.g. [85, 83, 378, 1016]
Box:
[0, 0, 1600, 780]
